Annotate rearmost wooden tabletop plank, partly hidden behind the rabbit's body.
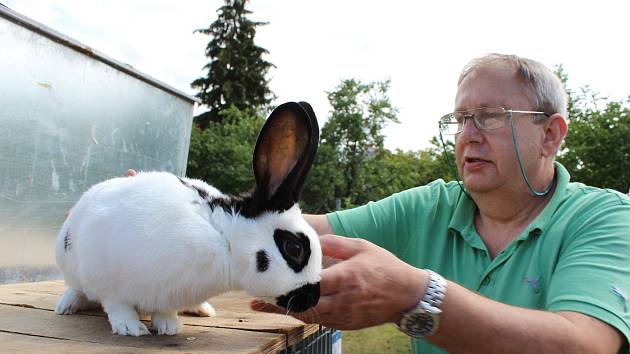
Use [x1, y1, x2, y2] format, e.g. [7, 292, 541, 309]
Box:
[0, 280, 320, 346]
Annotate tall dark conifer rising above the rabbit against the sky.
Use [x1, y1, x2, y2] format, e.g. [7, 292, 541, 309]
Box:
[191, 0, 274, 129]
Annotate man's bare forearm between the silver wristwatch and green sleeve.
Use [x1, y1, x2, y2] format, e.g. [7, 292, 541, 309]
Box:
[429, 282, 622, 354]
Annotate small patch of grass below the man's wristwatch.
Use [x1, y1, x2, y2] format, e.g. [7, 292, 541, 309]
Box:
[341, 324, 411, 354]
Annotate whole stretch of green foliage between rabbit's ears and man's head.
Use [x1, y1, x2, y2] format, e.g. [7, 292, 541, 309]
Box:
[302, 80, 449, 213]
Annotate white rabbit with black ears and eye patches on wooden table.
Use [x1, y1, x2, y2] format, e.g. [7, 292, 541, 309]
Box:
[55, 102, 322, 336]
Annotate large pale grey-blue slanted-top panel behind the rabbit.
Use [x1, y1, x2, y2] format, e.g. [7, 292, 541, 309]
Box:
[0, 13, 193, 283]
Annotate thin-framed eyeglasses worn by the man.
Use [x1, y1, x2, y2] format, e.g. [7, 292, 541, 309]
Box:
[439, 107, 550, 135]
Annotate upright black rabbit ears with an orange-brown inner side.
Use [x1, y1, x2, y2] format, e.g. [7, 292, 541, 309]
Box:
[253, 102, 319, 212]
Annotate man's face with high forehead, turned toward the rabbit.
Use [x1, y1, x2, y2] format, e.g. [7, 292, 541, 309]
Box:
[455, 64, 543, 193]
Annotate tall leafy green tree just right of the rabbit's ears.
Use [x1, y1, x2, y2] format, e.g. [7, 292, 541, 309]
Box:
[305, 80, 398, 210]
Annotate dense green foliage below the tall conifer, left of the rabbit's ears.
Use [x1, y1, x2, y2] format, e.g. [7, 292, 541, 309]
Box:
[187, 106, 264, 194]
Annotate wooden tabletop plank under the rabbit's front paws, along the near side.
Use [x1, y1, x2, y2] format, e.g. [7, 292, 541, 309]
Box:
[0, 305, 285, 353]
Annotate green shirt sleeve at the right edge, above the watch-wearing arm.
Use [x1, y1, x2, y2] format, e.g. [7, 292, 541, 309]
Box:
[547, 194, 630, 353]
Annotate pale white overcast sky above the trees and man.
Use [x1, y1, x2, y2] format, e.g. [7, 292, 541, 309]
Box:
[0, 0, 630, 150]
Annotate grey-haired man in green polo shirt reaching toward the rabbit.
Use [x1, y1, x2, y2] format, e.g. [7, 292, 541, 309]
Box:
[252, 54, 630, 353]
